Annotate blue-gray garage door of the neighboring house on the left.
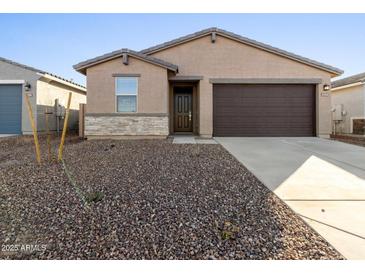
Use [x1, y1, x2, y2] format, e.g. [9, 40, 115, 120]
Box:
[0, 84, 22, 134]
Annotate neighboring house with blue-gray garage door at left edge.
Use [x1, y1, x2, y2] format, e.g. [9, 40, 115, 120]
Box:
[0, 57, 86, 134]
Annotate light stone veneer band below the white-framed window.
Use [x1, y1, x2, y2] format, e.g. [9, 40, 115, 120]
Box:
[85, 113, 169, 137]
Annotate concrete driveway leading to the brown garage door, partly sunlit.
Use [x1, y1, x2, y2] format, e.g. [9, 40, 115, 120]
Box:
[215, 137, 365, 259]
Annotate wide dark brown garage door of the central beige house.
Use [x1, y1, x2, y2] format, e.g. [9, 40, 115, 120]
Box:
[213, 84, 315, 137]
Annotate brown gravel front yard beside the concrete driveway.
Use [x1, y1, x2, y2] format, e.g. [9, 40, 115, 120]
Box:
[0, 137, 342, 259]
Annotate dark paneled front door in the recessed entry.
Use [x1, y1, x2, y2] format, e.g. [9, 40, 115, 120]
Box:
[174, 87, 193, 132]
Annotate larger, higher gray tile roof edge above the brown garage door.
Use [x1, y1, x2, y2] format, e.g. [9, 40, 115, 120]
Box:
[140, 28, 343, 75]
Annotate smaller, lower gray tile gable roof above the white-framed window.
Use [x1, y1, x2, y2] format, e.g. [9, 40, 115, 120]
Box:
[73, 49, 178, 73]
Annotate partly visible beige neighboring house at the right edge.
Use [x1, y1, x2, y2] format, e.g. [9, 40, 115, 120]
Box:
[331, 73, 365, 135]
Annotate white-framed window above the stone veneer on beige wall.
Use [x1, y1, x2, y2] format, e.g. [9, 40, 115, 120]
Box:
[115, 77, 138, 112]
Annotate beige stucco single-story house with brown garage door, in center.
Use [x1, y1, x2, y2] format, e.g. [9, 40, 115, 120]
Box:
[74, 28, 343, 138]
